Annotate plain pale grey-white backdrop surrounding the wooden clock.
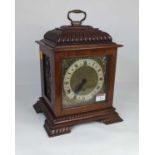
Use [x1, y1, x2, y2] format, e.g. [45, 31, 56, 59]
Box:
[16, 0, 138, 155]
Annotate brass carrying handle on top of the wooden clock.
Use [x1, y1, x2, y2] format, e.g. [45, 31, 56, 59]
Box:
[67, 10, 87, 26]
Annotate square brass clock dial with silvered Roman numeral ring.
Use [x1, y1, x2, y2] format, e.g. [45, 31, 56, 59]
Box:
[63, 57, 107, 107]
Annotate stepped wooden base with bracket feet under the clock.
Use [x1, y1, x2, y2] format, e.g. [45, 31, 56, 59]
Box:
[33, 97, 123, 137]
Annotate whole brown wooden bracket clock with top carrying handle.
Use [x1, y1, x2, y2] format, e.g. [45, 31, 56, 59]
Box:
[34, 10, 122, 136]
